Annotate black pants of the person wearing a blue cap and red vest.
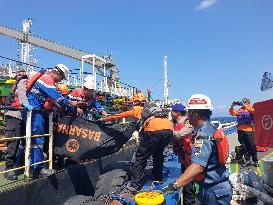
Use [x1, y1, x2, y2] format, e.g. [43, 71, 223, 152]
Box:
[180, 164, 195, 205]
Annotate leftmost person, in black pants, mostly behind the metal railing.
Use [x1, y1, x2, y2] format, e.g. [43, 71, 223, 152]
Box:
[4, 70, 28, 180]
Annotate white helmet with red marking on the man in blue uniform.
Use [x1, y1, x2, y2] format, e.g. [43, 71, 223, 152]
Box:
[186, 94, 213, 110]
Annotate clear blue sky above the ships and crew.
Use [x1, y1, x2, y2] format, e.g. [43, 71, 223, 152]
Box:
[0, 0, 273, 116]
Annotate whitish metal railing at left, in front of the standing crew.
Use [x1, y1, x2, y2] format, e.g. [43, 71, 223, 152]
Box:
[0, 106, 53, 178]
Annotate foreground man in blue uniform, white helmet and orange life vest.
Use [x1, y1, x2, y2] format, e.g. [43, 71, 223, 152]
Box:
[162, 94, 232, 205]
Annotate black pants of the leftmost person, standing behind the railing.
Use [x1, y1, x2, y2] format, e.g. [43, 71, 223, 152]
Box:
[5, 116, 26, 170]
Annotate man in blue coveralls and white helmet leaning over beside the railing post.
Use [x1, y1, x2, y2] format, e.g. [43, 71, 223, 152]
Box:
[24, 64, 77, 178]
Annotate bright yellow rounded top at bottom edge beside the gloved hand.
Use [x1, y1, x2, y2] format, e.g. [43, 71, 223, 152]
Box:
[135, 192, 165, 205]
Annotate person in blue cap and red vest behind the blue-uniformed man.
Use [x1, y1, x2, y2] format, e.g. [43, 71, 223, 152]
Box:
[171, 103, 195, 205]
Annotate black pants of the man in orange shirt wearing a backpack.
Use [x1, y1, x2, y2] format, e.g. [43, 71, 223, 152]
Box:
[131, 130, 173, 190]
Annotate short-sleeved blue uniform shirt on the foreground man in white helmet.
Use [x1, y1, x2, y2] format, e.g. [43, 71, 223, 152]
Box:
[191, 122, 229, 186]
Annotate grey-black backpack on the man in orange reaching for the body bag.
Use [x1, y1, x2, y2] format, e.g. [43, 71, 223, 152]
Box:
[138, 103, 169, 128]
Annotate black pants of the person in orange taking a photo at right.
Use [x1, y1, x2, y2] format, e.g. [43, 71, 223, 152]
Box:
[238, 130, 258, 162]
